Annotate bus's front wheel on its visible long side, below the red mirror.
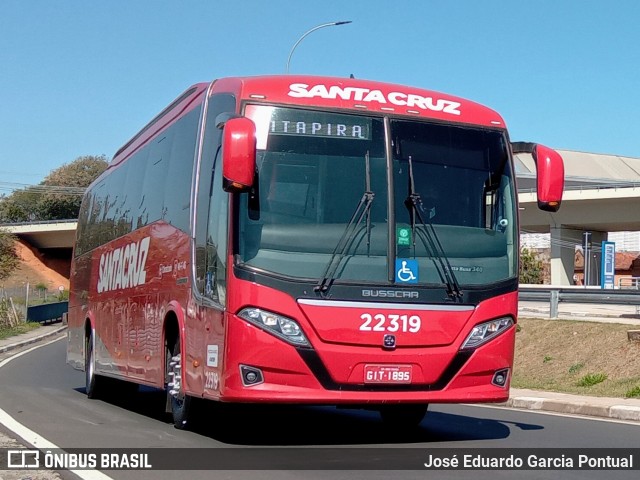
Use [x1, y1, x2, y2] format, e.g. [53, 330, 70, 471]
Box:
[165, 337, 193, 430]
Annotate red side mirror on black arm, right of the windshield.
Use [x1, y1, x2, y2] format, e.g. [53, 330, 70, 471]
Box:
[511, 142, 564, 212]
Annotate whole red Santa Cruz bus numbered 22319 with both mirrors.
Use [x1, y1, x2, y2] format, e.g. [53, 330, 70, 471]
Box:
[67, 76, 564, 428]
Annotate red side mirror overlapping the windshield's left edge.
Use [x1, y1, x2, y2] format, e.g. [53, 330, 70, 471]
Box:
[222, 117, 256, 192]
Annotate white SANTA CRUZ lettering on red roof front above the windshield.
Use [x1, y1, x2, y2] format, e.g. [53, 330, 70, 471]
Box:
[289, 83, 461, 115]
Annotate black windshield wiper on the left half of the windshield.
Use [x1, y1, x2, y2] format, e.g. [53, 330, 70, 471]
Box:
[313, 151, 375, 295]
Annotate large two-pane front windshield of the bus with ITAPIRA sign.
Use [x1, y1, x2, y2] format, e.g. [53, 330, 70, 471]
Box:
[236, 105, 517, 289]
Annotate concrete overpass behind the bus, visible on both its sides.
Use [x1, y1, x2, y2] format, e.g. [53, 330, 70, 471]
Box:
[4, 150, 640, 285]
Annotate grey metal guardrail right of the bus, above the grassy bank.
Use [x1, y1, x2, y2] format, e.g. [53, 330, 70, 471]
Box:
[518, 285, 640, 318]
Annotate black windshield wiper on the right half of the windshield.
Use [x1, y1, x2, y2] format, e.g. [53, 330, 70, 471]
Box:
[404, 156, 462, 300]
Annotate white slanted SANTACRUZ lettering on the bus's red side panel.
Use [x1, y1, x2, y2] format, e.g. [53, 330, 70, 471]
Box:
[97, 237, 151, 293]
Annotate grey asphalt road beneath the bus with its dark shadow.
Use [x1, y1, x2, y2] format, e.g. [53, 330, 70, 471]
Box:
[0, 340, 640, 480]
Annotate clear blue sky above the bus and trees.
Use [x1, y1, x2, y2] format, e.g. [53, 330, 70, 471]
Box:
[0, 0, 640, 194]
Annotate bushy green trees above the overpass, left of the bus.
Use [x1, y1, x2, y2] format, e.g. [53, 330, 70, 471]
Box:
[0, 155, 109, 222]
